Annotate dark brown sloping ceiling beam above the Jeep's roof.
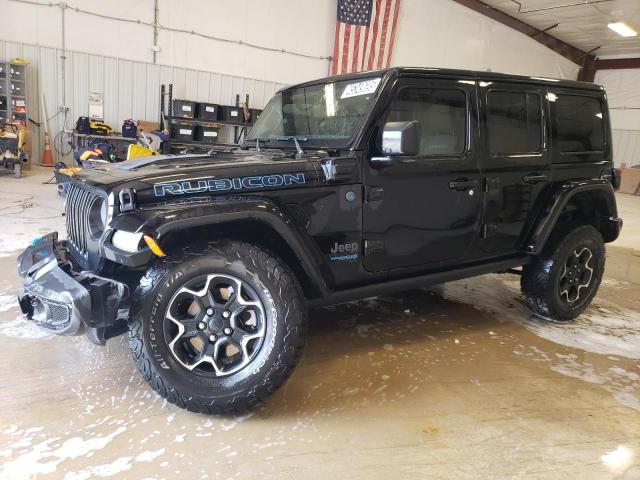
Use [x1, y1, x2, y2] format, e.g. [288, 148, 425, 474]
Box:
[453, 0, 595, 67]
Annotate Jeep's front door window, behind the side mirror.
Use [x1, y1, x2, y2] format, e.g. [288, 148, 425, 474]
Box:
[386, 88, 467, 156]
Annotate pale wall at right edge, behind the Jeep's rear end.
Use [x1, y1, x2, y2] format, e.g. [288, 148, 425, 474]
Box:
[595, 69, 640, 166]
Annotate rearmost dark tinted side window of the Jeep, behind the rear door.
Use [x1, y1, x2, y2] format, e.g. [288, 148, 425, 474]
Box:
[552, 95, 604, 152]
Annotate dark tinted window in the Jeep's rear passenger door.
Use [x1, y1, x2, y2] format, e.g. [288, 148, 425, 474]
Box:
[487, 90, 542, 154]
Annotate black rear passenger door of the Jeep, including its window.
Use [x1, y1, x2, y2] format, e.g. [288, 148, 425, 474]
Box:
[479, 82, 550, 254]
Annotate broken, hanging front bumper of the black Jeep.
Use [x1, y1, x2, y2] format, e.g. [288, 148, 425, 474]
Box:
[18, 232, 127, 345]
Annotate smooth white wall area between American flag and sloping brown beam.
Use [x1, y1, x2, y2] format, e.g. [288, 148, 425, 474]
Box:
[392, 0, 578, 80]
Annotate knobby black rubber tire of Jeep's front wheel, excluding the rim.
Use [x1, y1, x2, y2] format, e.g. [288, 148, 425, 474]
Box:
[129, 241, 307, 415]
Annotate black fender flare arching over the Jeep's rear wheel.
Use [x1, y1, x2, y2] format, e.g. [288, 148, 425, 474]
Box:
[525, 179, 622, 255]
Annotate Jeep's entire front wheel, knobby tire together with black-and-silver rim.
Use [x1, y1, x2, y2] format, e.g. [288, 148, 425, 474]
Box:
[129, 241, 307, 414]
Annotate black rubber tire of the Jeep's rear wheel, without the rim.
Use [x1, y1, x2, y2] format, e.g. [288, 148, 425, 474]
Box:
[520, 224, 605, 321]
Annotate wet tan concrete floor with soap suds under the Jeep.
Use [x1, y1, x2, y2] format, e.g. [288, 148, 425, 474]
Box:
[0, 170, 640, 480]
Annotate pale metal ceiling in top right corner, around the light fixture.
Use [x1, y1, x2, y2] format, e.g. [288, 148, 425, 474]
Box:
[482, 0, 640, 58]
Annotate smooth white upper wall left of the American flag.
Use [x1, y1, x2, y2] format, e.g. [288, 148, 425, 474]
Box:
[0, 0, 336, 83]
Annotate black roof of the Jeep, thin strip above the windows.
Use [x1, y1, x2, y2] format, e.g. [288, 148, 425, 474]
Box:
[282, 67, 604, 90]
